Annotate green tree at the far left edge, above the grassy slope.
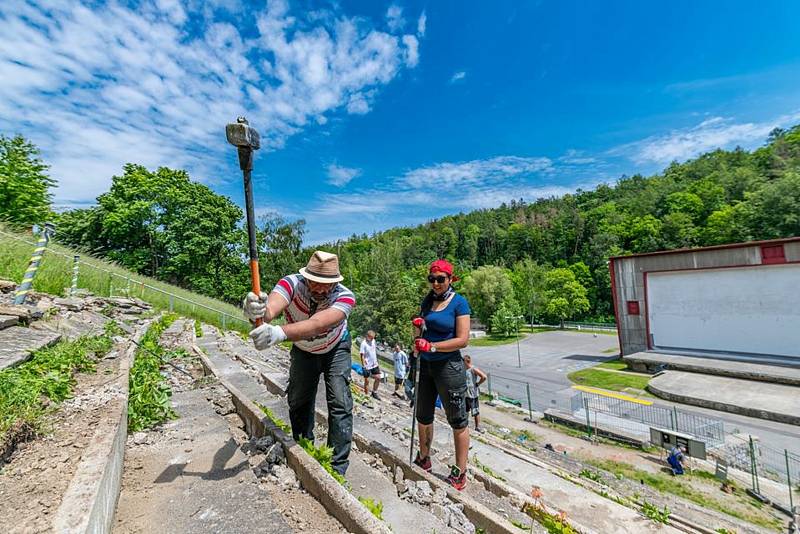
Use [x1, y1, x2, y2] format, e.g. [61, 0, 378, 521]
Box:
[0, 135, 55, 226]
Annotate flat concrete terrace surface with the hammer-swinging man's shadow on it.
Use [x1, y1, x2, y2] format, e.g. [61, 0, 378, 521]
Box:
[114, 389, 295, 534]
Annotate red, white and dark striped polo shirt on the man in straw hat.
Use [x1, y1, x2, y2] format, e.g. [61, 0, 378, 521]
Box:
[273, 274, 356, 354]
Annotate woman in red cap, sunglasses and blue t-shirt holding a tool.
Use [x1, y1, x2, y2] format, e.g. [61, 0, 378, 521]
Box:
[414, 260, 470, 490]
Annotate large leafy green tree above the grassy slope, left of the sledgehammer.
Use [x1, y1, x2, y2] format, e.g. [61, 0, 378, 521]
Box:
[57, 164, 247, 303]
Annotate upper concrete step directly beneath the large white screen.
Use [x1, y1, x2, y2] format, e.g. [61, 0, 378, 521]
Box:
[623, 352, 800, 386]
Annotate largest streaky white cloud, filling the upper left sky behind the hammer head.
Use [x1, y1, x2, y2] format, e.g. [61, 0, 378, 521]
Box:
[0, 0, 419, 204]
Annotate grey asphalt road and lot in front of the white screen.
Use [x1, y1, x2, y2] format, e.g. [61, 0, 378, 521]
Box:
[466, 331, 800, 453]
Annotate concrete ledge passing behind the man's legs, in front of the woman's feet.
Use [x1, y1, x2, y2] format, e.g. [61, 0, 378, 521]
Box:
[255, 373, 519, 534]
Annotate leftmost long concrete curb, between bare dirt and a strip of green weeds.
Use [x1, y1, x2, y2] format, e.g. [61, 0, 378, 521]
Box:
[53, 325, 148, 534]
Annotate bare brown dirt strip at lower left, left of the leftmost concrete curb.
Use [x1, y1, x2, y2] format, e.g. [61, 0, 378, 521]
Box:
[0, 352, 121, 533]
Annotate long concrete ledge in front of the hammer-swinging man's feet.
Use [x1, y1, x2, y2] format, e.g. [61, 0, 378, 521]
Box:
[192, 345, 391, 534]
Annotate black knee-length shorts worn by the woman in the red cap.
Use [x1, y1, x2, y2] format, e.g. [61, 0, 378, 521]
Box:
[417, 352, 469, 430]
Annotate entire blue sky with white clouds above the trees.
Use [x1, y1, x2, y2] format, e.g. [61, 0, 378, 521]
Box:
[0, 0, 800, 243]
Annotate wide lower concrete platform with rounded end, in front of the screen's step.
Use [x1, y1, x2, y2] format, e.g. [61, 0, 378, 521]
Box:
[647, 371, 800, 425]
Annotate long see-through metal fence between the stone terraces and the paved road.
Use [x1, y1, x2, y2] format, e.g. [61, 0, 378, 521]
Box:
[486, 373, 800, 513]
